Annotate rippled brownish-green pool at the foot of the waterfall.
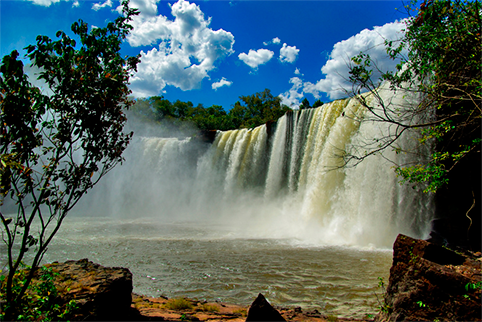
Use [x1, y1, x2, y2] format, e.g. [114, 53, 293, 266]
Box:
[44, 217, 392, 317]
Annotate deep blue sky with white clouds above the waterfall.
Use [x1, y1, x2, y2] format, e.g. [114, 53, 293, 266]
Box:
[0, 0, 407, 110]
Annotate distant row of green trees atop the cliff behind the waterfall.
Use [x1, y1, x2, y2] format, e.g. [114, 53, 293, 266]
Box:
[133, 89, 292, 131]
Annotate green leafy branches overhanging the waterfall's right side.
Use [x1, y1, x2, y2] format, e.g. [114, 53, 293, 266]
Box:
[350, 0, 482, 192]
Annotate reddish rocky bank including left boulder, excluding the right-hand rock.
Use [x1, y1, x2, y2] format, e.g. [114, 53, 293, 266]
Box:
[38, 259, 372, 322]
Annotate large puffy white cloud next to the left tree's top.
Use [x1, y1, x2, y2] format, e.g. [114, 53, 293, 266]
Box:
[127, 0, 234, 96]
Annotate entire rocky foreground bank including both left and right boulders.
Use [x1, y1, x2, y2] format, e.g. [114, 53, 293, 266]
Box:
[36, 235, 482, 322]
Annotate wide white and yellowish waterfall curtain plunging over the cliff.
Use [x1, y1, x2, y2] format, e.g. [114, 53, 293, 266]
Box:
[79, 85, 432, 247]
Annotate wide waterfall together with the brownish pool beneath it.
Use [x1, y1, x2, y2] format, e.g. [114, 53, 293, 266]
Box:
[41, 85, 431, 318]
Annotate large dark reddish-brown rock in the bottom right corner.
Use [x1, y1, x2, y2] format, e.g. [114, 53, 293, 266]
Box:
[375, 235, 482, 322]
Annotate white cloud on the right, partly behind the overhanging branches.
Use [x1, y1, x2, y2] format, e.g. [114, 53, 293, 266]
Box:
[303, 21, 405, 99]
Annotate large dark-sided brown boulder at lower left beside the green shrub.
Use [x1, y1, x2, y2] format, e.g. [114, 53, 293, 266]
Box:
[47, 259, 140, 322]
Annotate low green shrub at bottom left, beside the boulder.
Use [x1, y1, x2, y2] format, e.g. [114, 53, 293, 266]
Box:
[0, 266, 77, 322]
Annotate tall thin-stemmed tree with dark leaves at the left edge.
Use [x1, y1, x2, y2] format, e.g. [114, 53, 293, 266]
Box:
[0, 1, 139, 321]
